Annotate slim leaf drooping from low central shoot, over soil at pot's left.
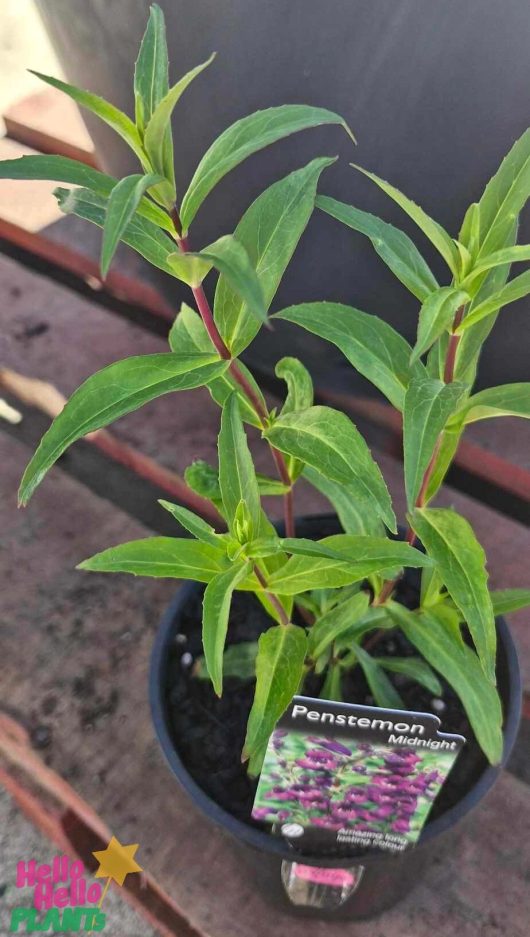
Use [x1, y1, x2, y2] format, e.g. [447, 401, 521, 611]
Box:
[202, 563, 249, 696]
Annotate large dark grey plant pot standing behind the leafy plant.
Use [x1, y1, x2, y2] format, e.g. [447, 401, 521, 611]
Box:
[39, 0, 530, 391]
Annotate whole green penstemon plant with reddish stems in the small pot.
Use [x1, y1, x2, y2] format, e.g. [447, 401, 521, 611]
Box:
[5, 5, 530, 774]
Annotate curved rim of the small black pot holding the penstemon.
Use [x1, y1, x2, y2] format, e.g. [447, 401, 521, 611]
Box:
[149, 515, 522, 867]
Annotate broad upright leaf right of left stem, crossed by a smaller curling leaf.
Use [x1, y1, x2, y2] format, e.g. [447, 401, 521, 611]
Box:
[214, 157, 334, 355]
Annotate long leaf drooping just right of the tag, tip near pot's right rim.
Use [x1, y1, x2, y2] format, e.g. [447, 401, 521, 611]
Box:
[388, 602, 503, 764]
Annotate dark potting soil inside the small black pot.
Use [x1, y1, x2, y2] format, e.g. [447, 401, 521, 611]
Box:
[166, 517, 487, 828]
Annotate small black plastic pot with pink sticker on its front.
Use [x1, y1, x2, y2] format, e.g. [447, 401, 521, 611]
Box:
[150, 517, 521, 920]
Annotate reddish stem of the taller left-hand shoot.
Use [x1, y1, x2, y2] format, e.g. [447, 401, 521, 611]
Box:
[170, 206, 296, 537]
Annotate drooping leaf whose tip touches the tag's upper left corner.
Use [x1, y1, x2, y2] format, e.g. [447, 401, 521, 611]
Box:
[243, 625, 307, 776]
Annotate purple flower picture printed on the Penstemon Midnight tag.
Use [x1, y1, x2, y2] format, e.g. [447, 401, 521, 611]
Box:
[252, 729, 454, 845]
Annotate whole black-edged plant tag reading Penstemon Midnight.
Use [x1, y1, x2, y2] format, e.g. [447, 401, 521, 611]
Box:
[252, 696, 465, 853]
